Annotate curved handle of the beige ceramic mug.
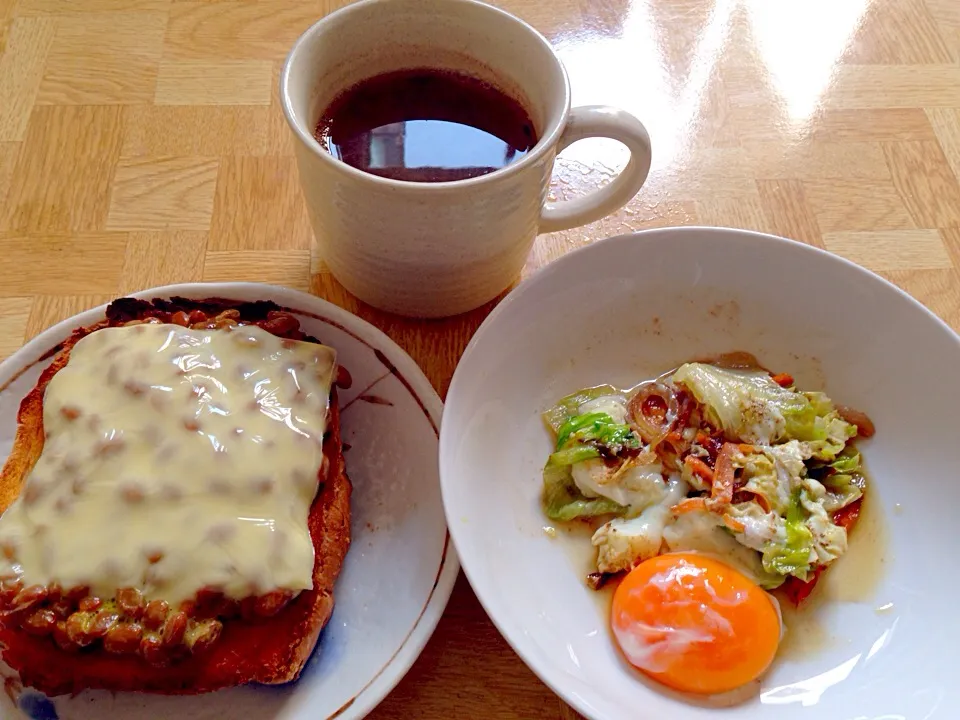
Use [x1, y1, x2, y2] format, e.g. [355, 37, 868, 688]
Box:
[539, 105, 652, 233]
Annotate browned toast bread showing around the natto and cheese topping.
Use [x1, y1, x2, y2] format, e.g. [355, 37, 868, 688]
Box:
[0, 298, 351, 695]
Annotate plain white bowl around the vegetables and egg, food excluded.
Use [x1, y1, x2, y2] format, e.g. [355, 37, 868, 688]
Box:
[440, 228, 960, 720]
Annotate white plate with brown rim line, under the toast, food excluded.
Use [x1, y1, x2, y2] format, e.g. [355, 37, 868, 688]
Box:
[0, 283, 459, 720]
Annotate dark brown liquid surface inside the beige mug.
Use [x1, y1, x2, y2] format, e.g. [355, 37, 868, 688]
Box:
[314, 68, 537, 182]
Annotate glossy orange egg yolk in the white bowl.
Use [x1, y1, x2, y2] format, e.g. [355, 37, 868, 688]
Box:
[610, 553, 780, 694]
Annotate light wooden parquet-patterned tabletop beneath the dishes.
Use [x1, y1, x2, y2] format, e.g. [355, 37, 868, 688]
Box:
[0, 0, 960, 718]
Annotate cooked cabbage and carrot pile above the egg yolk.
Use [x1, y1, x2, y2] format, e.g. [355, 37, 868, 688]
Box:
[542, 362, 865, 589]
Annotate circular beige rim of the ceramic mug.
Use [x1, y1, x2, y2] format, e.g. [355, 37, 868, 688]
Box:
[280, 0, 570, 194]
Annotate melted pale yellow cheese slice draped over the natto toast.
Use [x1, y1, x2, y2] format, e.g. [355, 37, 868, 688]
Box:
[0, 324, 336, 604]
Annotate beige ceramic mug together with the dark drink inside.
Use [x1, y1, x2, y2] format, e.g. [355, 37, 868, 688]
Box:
[280, 0, 650, 317]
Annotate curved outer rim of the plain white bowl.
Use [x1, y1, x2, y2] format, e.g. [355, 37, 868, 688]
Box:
[438, 225, 960, 718]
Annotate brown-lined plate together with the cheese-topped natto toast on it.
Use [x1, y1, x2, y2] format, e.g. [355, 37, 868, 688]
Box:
[0, 283, 459, 720]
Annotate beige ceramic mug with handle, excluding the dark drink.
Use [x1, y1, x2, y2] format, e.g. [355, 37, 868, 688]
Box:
[280, 0, 651, 317]
